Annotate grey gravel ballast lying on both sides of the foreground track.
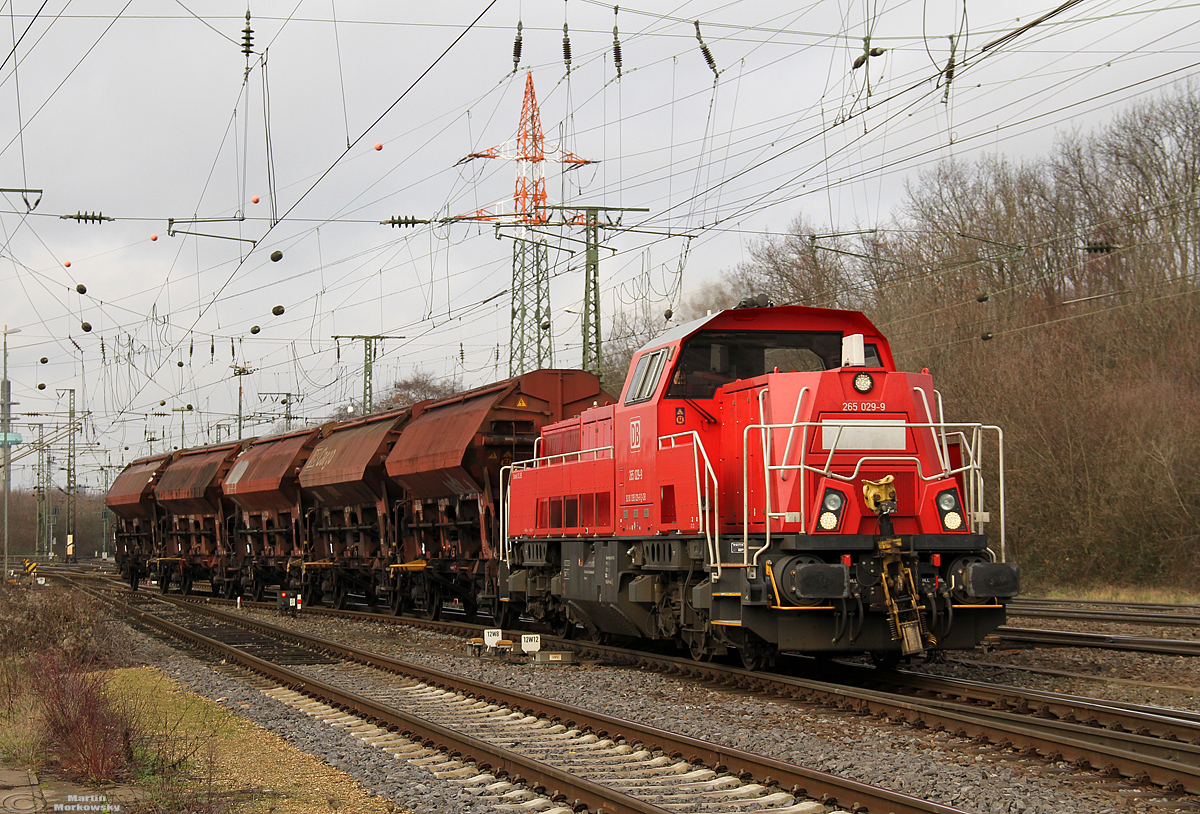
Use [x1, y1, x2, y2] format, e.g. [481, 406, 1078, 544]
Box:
[117, 609, 1200, 814]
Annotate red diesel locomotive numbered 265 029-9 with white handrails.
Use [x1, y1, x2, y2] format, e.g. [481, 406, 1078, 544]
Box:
[500, 298, 1019, 669]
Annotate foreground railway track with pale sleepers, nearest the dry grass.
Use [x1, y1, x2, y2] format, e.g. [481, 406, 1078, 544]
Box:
[77, 581, 974, 814]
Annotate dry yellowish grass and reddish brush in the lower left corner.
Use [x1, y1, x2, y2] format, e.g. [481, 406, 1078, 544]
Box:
[0, 585, 394, 814]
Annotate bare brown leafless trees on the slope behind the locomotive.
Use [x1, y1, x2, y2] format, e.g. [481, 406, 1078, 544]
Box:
[605, 84, 1200, 587]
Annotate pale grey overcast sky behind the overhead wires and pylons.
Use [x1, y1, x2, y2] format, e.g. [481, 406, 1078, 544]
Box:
[0, 0, 1200, 485]
